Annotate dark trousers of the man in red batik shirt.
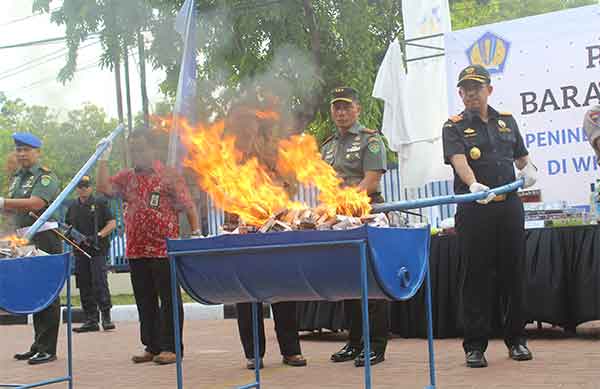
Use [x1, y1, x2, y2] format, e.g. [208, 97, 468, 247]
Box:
[129, 258, 183, 354]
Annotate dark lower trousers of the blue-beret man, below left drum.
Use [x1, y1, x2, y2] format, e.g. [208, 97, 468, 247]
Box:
[31, 298, 60, 355]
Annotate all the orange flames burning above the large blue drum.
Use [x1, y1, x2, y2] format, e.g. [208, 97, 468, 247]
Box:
[153, 111, 370, 226]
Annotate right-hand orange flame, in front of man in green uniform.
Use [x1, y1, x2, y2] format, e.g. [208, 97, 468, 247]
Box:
[277, 135, 371, 216]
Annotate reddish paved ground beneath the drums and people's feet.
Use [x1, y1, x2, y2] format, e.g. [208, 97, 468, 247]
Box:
[0, 320, 600, 389]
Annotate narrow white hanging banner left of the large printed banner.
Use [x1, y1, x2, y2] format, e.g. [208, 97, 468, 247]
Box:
[373, 0, 452, 188]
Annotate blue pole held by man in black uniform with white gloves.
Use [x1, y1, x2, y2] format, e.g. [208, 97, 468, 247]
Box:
[371, 178, 524, 213]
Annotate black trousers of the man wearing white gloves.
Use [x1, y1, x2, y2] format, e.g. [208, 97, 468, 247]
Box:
[456, 194, 526, 352]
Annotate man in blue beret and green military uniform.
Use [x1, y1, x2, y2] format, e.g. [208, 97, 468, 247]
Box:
[0, 133, 62, 365]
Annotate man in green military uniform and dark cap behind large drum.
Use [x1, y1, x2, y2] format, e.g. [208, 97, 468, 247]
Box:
[321, 87, 389, 367]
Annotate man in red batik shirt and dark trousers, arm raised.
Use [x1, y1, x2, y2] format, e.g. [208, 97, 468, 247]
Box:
[97, 129, 199, 365]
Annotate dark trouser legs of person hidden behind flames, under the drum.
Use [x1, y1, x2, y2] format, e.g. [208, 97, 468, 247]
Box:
[236, 301, 302, 358]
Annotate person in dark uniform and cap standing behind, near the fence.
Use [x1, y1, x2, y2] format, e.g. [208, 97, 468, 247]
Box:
[65, 176, 116, 332]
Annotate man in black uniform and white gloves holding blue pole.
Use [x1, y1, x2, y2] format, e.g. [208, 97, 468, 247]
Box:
[442, 65, 537, 367]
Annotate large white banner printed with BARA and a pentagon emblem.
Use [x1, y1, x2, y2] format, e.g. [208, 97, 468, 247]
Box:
[445, 5, 600, 205]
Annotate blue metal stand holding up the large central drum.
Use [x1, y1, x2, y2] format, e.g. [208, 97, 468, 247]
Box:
[169, 235, 435, 389]
